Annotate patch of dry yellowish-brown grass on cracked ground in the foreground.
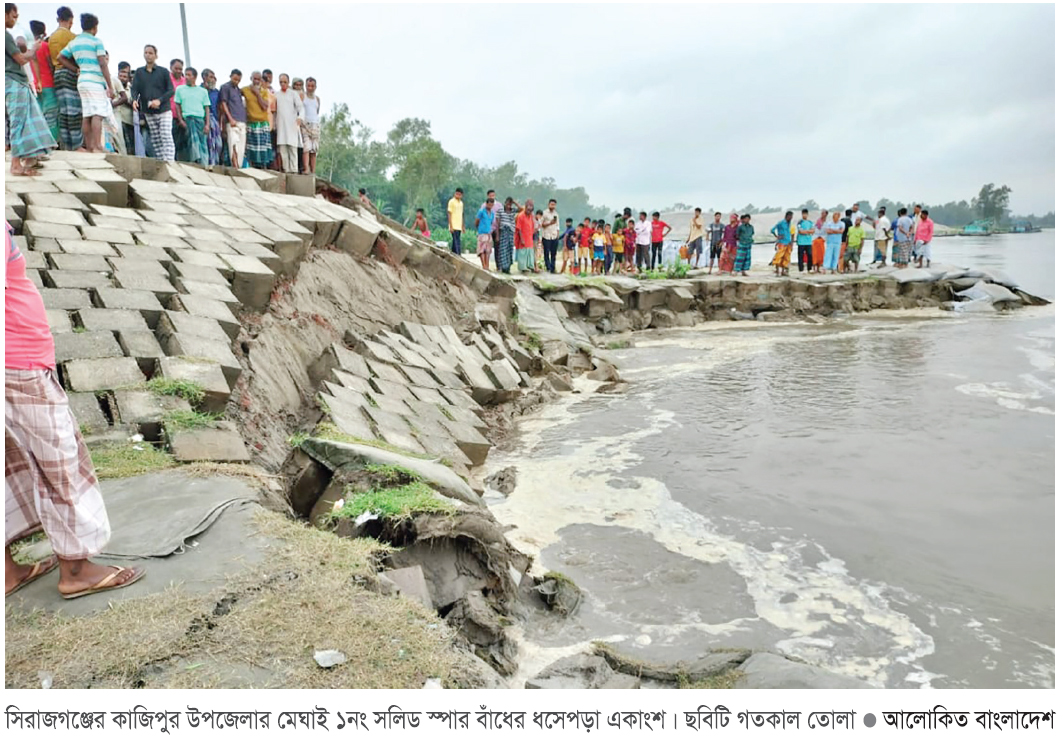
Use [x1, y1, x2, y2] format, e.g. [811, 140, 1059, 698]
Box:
[5, 511, 461, 689]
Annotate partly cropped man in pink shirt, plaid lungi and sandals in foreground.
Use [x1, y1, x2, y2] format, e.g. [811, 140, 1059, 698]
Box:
[3, 224, 145, 598]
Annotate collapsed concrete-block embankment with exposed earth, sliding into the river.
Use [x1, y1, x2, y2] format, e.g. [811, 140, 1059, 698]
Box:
[7, 153, 1041, 686]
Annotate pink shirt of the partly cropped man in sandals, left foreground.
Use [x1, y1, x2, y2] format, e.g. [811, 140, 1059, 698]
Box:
[3, 222, 55, 369]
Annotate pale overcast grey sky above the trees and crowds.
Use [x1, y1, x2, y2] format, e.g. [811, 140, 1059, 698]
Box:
[19, 2, 1056, 214]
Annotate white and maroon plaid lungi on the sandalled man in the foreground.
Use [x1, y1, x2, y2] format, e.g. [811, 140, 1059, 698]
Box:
[4, 369, 111, 560]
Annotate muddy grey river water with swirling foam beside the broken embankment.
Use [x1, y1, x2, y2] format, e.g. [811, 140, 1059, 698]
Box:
[488, 232, 1056, 688]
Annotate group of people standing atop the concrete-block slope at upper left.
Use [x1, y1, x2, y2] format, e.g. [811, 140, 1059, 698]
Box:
[4, 3, 321, 175]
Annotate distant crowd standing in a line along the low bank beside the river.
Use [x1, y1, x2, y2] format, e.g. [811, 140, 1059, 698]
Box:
[435, 188, 934, 276]
